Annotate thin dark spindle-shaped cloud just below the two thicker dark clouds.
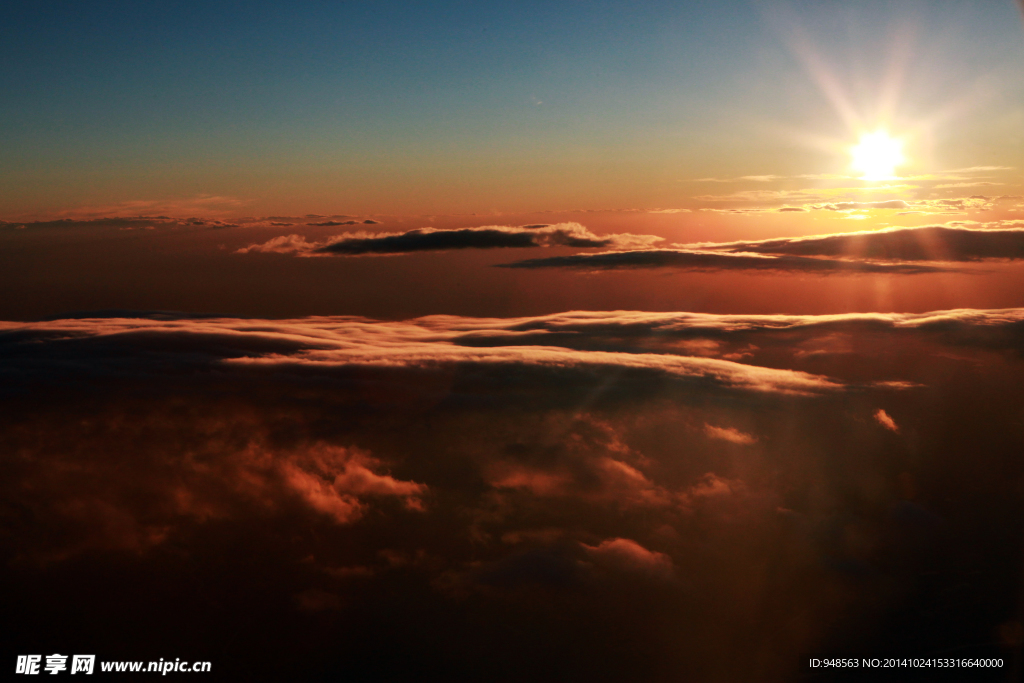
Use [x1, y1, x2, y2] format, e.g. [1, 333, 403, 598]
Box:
[499, 245, 948, 275]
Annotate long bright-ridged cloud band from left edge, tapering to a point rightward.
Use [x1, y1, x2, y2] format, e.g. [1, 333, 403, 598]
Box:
[0, 315, 872, 405]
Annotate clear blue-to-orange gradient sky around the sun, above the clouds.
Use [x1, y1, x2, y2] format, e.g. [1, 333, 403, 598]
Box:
[0, 0, 1024, 219]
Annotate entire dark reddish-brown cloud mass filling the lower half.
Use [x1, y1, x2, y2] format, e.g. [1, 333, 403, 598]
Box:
[0, 309, 1024, 681]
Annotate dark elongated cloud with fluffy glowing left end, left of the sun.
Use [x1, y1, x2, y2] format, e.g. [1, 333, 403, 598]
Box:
[239, 223, 662, 256]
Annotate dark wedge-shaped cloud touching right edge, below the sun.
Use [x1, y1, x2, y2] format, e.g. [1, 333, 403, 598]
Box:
[699, 225, 1024, 261]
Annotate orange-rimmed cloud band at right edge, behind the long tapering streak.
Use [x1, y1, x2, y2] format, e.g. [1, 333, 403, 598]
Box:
[436, 308, 1024, 366]
